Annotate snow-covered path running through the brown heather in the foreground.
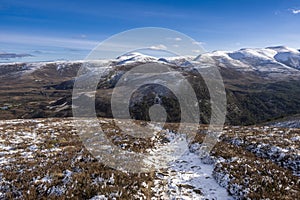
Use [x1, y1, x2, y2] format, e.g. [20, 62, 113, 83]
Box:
[145, 126, 232, 200]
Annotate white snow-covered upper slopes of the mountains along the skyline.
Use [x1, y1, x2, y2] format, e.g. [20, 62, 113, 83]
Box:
[0, 46, 300, 78]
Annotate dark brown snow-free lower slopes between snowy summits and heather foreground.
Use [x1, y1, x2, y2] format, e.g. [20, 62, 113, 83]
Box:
[0, 64, 300, 125]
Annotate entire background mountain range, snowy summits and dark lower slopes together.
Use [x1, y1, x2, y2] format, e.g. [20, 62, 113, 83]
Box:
[0, 46, 300, 125]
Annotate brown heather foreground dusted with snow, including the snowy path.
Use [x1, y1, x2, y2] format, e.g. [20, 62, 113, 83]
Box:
[0, 118, 300, 199]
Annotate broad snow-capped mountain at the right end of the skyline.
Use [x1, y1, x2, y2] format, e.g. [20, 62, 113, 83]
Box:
[195, 46, 300, 77]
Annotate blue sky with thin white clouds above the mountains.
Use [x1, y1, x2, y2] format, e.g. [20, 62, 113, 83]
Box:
[0, 0, 300, 62]
